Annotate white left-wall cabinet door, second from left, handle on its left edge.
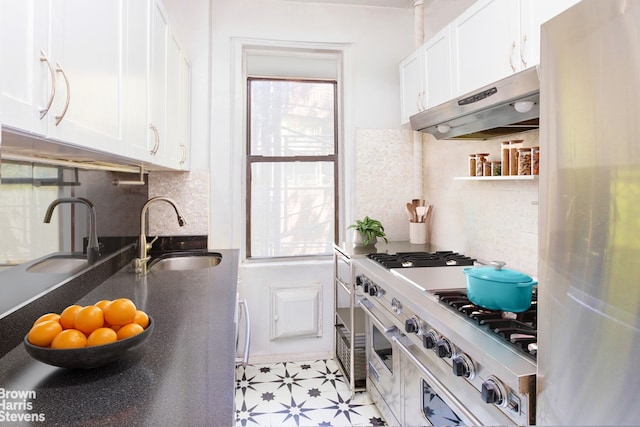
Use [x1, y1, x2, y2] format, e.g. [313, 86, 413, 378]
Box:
[48, 0, 124, 154]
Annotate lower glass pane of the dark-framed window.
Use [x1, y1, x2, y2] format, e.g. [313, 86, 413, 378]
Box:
[251, 162, 335, 257]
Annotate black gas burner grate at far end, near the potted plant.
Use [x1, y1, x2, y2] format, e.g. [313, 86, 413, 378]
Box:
[367, 251, 475, 268]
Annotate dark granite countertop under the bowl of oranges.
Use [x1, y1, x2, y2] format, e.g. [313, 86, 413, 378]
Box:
[0, 250, 238, 426]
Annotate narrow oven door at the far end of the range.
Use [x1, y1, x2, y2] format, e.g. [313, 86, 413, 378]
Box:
[360, 298, 402, 425]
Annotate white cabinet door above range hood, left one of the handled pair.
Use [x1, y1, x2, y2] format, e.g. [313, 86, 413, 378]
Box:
[453, 0, 520, 95]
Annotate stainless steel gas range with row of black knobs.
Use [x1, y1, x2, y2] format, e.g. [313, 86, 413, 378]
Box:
[354, 252, 537, 425]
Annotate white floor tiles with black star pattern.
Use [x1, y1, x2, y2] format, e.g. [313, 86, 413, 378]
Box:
[236, 360, 386, 427]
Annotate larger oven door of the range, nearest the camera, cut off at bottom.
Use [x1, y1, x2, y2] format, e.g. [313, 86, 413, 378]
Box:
[394, 338, 488, 426]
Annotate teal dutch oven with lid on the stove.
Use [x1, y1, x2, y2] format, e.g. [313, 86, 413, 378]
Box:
[463, 261, 538, 313]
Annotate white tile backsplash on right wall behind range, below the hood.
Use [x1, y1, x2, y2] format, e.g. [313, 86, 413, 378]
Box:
[423, 131, 544, 276]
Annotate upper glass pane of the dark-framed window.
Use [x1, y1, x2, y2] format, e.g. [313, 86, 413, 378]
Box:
[250, 80, 335, 156]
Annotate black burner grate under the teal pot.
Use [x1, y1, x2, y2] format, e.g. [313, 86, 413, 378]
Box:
[434, 289, 538, 359]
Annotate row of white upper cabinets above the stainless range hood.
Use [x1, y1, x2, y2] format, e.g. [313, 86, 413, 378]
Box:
[400, 0, 580, 124]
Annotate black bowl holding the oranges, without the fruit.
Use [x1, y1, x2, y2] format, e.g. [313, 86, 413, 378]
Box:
[24, 316, 154, 369]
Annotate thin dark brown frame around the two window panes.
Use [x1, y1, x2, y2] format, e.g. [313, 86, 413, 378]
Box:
[245, 76, 341, 260]
